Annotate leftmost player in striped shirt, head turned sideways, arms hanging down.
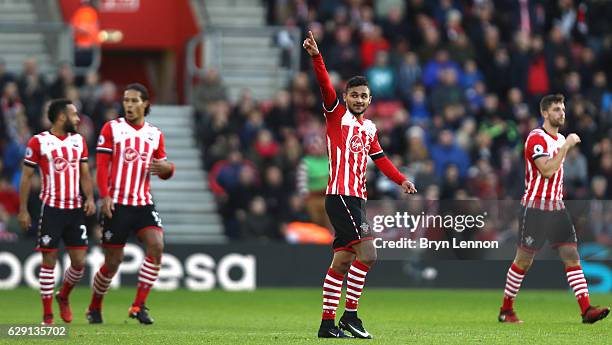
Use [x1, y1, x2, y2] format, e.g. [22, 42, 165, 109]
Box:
[18, 99, 96, 325]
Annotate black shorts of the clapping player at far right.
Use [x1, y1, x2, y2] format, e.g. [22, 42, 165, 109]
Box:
[518, 206, 578, 252]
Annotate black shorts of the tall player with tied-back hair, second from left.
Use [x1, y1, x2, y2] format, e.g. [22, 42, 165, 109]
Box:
[102, 204, 163, 247]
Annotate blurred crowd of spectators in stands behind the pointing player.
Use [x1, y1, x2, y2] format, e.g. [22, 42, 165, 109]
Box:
[195, 0, 612, 245]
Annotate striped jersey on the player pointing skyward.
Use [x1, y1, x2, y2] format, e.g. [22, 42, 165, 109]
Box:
[323, 100, 383, 199]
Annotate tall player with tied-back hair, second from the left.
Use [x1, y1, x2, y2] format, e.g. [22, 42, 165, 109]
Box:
[87, 84, 174, 325]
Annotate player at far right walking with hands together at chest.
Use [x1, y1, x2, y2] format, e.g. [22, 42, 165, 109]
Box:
[498, 94, 610, 323]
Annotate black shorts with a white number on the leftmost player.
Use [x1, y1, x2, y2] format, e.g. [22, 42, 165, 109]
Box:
[36, 204, 87, 252]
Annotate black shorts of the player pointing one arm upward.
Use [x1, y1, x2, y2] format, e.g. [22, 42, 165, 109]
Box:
[325, 195, 372, 252]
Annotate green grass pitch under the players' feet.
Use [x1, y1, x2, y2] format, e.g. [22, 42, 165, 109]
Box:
[0, 288, 612, 345]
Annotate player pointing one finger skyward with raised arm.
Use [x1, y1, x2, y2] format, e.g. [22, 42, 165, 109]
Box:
[303, 32, 416, 339]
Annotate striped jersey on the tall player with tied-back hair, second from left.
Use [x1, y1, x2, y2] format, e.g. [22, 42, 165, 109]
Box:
[96, 118, 166, 206]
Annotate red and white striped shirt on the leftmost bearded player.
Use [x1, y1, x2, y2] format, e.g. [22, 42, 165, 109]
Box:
[23, 131, 88, 209]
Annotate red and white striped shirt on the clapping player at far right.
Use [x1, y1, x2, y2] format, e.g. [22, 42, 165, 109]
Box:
[521, 128, 565, 211]
